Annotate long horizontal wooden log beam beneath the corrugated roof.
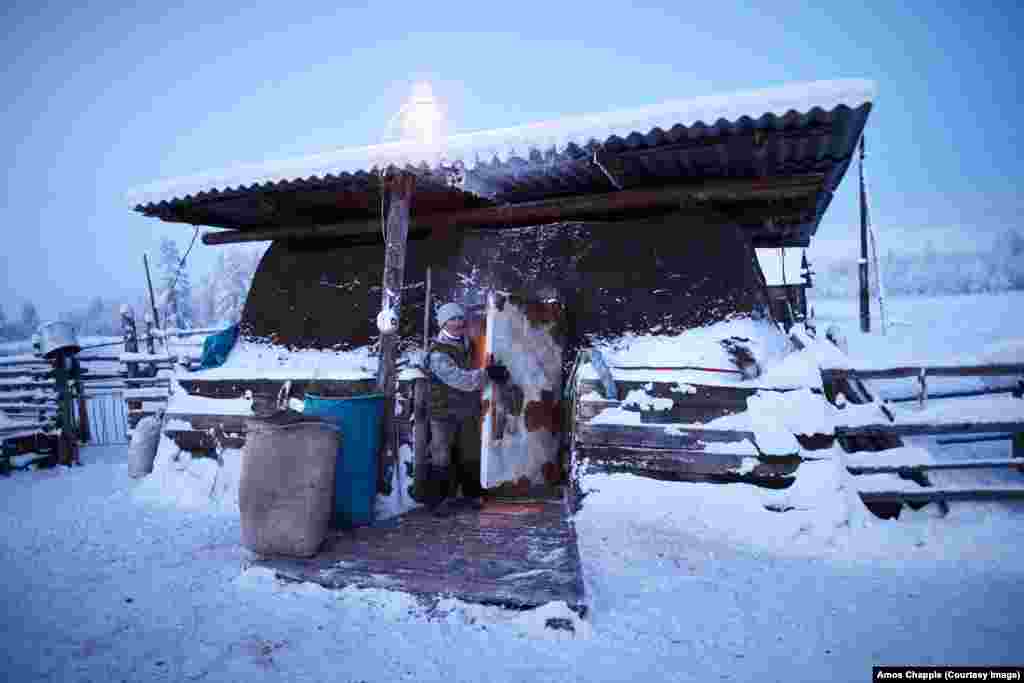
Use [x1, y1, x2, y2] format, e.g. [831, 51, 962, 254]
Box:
[203, 173, 824, 245]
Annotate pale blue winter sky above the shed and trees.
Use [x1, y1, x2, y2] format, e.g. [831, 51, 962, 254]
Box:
[0, 0, 1024, 317]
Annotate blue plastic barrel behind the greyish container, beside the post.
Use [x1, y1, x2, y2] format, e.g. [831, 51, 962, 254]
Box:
[303, 393, 385, 527]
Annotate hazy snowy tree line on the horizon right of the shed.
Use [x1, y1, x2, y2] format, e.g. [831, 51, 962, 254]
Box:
[812, 230, 1024, 298]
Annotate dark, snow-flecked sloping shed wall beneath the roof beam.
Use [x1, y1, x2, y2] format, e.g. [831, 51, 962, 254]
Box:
[243, 214, 766, 358]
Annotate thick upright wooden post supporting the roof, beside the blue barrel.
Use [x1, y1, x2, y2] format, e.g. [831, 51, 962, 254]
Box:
[377, 171, 416, 495]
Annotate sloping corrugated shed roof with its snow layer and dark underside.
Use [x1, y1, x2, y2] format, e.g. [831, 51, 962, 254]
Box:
[129, 80, 876, 246]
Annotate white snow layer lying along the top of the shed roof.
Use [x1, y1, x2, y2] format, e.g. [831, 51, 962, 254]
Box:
[127, 79, 877, 208]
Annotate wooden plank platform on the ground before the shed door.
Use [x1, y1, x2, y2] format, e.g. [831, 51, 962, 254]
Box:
[253, 491, 586, 613]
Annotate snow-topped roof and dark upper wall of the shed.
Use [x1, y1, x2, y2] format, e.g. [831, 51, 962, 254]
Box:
[130, 80, 874, 348]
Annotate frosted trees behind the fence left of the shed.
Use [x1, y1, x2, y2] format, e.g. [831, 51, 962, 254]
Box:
[0, 242, 260, 341]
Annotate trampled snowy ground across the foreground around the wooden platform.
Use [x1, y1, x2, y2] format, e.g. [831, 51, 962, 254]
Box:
[0, 447, 1024, 682]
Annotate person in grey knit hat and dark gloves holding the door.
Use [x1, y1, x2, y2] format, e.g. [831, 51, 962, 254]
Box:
[426, 302, 509, 516]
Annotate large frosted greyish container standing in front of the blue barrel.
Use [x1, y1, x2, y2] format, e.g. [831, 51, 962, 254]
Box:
[239, 411, 341, 557]
